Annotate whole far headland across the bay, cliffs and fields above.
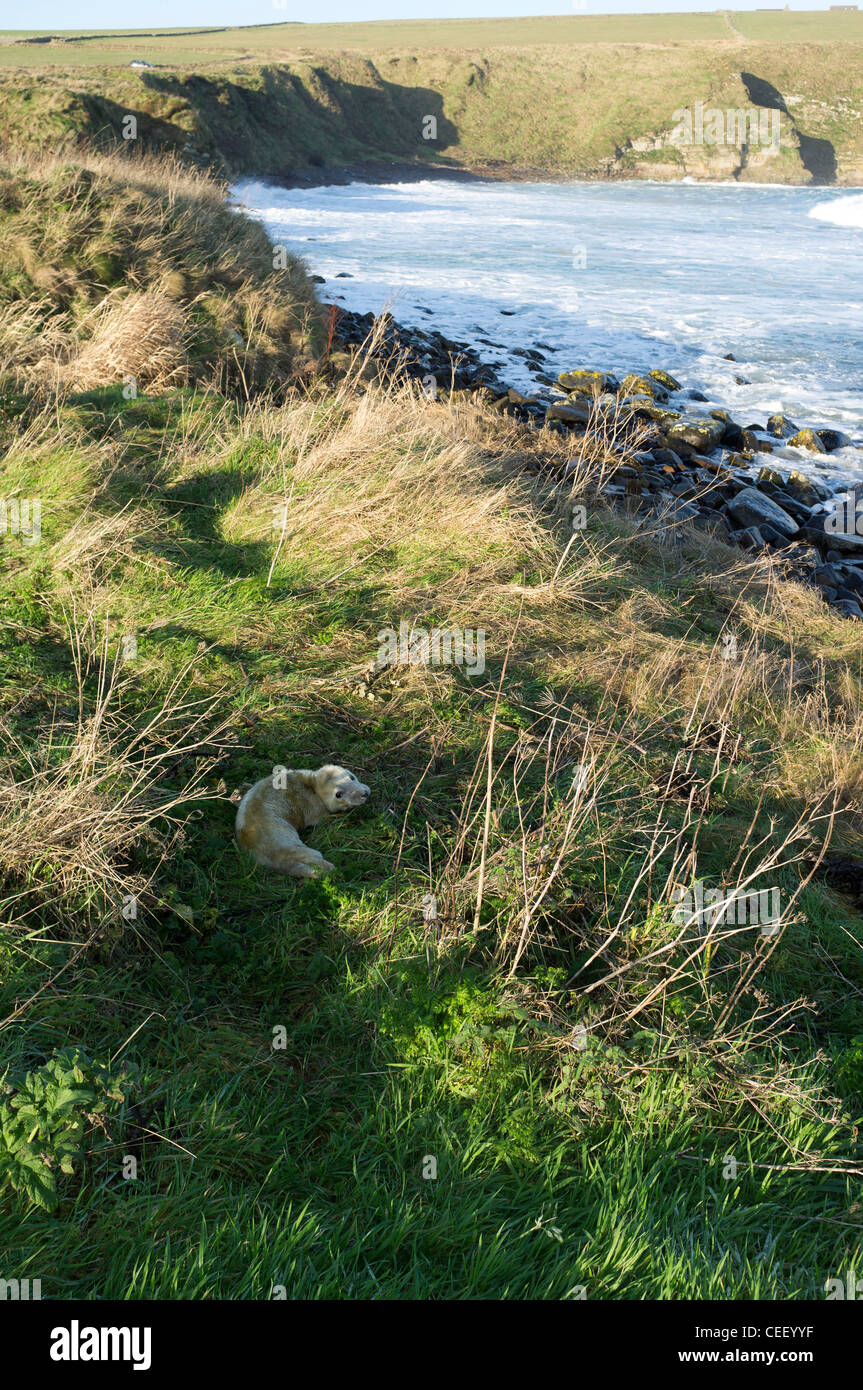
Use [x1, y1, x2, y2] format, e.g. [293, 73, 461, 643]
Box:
[0, 14, 863, 185]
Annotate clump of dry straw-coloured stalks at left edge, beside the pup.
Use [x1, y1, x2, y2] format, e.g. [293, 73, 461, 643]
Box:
[0, 607, 228, 944]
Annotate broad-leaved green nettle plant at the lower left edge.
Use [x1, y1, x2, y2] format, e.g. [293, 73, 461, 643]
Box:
[0, 1048, 129, 1211]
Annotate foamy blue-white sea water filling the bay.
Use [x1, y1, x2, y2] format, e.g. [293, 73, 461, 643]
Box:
[235, 179, 863, 477]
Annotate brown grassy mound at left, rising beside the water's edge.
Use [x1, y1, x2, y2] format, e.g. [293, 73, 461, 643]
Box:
[0, 147, 322, 389]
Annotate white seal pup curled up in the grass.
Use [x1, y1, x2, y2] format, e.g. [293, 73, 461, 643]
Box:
[235, 763, 370, 878]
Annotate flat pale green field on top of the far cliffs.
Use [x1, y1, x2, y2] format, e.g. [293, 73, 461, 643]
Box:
[0, 11, 863, 67]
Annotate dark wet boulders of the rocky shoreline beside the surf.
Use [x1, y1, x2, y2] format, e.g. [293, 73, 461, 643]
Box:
[334, 309, 863, 621]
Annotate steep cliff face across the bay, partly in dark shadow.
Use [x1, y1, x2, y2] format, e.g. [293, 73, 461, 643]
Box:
[0, 42, 863, 185]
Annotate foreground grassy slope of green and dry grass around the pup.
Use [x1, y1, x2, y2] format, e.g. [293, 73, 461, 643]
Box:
[0, 146, 863, 1298]
